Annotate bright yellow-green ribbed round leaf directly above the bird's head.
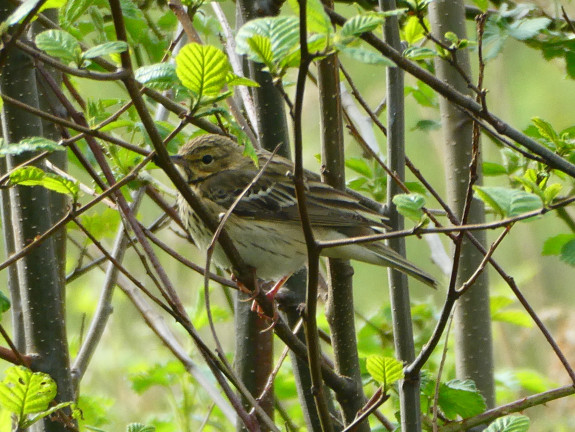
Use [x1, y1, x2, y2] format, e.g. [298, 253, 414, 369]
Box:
[176, 43, 230, 98]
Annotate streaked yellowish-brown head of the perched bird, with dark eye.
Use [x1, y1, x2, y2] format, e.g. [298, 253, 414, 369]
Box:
[171, 134, 245, 183]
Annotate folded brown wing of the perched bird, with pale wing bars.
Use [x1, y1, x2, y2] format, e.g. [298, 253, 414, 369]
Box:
[199, 167, 386, 228]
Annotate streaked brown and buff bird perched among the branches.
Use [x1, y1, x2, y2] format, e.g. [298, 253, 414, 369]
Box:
[171, 134, 436, 297]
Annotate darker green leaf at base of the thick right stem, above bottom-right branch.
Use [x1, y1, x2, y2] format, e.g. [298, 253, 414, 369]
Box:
[439, 380, 486, 420]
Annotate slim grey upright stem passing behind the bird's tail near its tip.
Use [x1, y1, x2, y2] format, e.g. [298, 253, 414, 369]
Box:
[380, 0, 421, 431]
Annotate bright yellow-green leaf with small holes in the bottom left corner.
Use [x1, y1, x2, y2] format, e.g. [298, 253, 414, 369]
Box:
[0, 366, 56, 420]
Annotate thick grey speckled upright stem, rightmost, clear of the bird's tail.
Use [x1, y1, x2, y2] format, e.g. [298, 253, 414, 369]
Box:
[429, 0, 495, 407]
